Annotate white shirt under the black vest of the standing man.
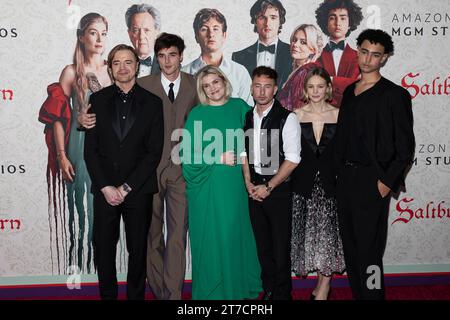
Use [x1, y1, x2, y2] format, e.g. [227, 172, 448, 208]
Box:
[253, 101, 301, 174]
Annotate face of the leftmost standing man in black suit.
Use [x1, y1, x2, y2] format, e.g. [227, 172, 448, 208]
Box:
[111, 50, 138, 83]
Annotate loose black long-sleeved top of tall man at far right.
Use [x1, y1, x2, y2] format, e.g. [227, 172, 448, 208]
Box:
[336, 78, 415, 192]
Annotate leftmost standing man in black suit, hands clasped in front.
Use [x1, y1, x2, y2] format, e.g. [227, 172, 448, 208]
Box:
[84, 44, 164, 299]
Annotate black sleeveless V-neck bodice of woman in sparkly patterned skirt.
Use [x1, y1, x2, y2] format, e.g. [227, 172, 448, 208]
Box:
[291, 122, 337, 197]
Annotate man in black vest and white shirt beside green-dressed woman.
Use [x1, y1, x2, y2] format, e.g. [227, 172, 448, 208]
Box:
[243, 66, 300, 300]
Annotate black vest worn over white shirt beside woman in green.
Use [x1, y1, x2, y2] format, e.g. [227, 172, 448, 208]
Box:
[244, 99, 291, 180]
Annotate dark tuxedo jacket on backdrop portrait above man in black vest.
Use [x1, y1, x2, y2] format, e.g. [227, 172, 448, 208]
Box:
[231, 40, 292, 89]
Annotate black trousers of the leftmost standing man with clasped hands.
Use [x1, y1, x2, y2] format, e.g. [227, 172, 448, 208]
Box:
[93, 194, 153, 300]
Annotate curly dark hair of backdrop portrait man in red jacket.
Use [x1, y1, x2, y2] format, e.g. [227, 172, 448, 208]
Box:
[316, 0, 363, 37]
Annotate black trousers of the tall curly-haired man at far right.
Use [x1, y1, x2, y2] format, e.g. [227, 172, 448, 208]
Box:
[337, 166, 390, 300]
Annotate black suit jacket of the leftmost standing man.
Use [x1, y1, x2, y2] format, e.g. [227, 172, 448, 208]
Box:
[84, 85, 164, 197]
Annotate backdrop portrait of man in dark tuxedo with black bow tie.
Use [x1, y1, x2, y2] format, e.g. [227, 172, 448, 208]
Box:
[231, 0, 292, 88]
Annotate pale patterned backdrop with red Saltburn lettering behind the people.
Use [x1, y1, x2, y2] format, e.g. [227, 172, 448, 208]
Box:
[0, 0, 450, 285]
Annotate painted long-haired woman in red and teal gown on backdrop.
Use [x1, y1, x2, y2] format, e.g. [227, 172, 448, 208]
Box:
[39, 12, 112, 273]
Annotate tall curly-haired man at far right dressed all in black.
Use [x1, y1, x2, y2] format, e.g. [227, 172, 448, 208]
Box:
[336, 29, 415, 299]
